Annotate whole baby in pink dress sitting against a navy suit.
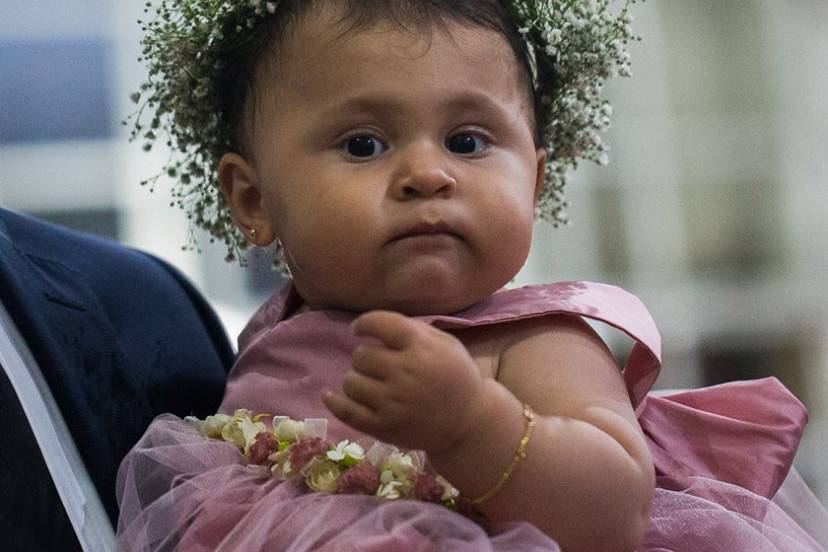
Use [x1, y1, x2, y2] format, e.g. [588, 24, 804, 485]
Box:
[119, 0, 828, 552]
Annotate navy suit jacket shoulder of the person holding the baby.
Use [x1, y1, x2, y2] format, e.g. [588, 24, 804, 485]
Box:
[0, 209, 233, 548]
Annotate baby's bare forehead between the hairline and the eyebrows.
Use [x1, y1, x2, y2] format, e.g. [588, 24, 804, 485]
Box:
[270, 21, 526, 99]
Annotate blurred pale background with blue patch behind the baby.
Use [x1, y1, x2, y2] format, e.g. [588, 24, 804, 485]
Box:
[0, 0, 828, 503]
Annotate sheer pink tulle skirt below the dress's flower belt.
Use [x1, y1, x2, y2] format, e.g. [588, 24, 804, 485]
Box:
[117, 416, 828, 552]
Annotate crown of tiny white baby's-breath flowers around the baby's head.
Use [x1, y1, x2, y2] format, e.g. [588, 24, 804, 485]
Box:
[124, 0, 640, 260]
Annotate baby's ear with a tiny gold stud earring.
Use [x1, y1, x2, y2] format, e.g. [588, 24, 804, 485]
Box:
[218, 153, 275, 246]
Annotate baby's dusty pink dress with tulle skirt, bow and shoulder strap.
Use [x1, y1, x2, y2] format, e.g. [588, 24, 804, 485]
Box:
[118, 282, 828, 552]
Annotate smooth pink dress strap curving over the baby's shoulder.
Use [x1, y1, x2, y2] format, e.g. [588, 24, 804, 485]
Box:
[423, 282, 661, 412]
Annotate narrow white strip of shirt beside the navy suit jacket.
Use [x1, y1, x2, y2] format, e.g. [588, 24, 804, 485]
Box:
[0, 303, 115, 552]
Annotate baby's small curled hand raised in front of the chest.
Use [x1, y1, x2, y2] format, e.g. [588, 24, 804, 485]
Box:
[324, 311, 484, 452]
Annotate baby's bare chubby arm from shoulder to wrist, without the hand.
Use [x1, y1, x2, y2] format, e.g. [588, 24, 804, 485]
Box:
[440, 316, 654, 552]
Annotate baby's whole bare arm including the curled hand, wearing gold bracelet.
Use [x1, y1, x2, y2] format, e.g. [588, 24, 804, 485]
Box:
[326, 313, 654, 552]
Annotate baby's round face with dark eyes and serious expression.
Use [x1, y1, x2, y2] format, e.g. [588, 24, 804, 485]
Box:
[246, 5, 545, 315]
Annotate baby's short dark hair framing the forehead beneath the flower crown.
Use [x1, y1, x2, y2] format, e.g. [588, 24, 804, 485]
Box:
[218, 0, 542, 160]
